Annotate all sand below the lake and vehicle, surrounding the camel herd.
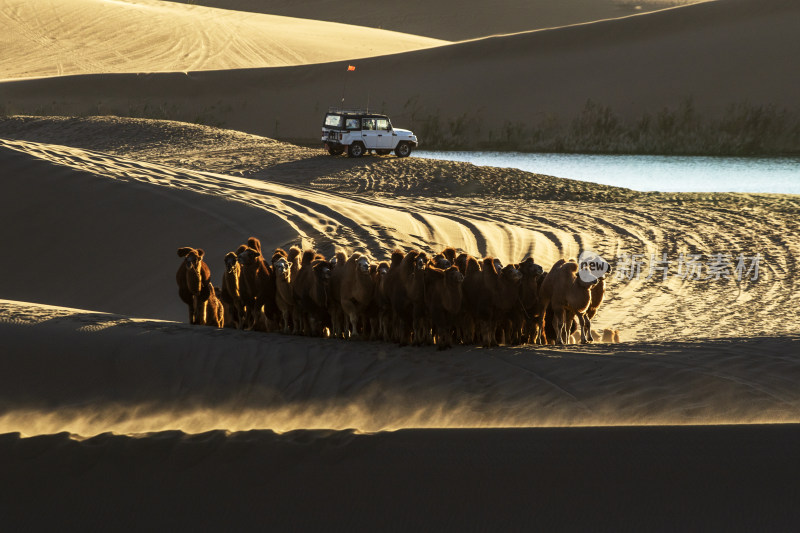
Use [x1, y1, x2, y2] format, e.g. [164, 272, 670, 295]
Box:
[0, 117, 800, 530]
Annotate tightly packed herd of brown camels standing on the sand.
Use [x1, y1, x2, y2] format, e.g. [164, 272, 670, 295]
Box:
[176, 237, 619, 350]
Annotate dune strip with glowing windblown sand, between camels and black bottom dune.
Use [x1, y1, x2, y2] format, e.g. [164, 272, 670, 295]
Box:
[0, 300, 800, 436]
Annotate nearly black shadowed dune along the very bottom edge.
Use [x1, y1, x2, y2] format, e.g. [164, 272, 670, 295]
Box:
[0, 420, 800, 532]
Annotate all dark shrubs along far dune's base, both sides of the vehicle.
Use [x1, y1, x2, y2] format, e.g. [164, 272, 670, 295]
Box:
[6, 96, 800, 156]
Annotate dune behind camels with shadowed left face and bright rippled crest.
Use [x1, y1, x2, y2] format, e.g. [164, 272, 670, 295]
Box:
[0, 136, 557, 320]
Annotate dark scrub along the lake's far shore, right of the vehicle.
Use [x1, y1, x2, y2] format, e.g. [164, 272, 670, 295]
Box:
[403, 98, 800, 156]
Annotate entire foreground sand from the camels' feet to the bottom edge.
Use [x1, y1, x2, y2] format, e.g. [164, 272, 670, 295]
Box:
[0, 300, 800, 531]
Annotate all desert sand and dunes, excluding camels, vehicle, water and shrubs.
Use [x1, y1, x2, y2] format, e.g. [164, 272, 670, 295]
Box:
[0, 0, 800, 531]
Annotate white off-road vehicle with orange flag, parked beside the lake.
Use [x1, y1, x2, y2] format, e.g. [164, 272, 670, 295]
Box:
[322, 108, 418, 157]
